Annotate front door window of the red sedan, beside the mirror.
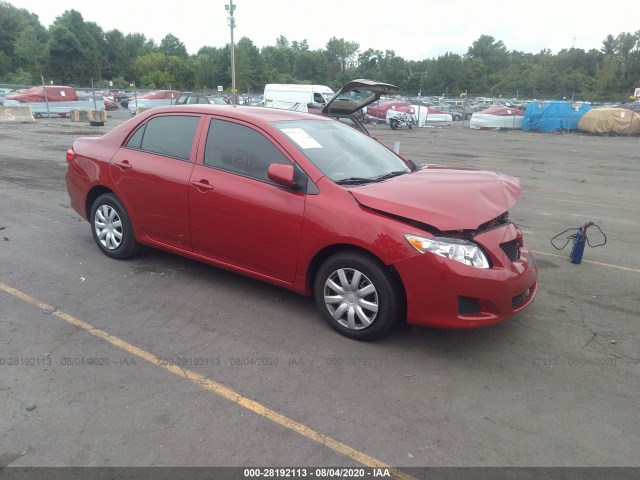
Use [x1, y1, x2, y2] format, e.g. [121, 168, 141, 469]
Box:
[204, 120, 291, 181]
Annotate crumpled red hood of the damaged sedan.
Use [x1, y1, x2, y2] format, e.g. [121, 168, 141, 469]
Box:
[350, 167, 521, 231]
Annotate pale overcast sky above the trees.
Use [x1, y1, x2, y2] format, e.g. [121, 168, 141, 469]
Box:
[8, 0, 640, 60]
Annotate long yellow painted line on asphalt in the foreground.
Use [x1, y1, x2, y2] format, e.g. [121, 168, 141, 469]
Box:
[0, 282, 416, 480]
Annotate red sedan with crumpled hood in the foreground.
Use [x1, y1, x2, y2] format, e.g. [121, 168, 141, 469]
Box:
[66, 105, 538, 339]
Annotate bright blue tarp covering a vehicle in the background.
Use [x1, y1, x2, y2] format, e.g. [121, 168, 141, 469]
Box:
[522, 100, 591, 132]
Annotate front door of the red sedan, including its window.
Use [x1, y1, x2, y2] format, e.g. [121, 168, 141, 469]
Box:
[189, 119, 305, 282]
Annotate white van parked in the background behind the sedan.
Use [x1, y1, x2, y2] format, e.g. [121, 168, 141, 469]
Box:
[264, 83, 334, 111]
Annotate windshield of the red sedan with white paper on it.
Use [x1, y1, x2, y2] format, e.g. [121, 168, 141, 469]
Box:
[275, 120, 411, 185]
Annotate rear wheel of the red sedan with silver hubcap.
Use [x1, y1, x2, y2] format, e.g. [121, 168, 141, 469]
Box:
[89, 193, 140, 260]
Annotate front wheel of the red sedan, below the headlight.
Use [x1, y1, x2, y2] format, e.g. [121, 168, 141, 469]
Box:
[314, 251, 404, 340]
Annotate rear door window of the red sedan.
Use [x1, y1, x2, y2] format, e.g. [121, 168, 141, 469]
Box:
[127, 115, 200, 160]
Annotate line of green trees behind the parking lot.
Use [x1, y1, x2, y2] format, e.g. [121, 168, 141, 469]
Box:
[0, 1, 640, 102]
